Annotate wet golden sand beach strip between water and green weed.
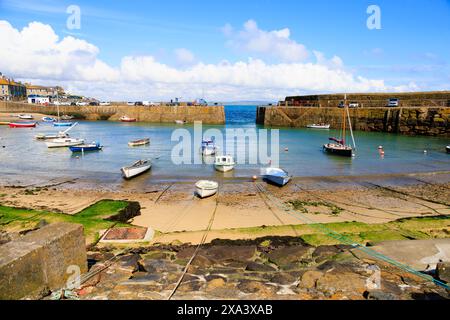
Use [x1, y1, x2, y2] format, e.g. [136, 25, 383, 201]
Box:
[0, 172, 450, 243]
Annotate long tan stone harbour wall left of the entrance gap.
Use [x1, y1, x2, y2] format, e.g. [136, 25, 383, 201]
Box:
[0, 101, 225, 124]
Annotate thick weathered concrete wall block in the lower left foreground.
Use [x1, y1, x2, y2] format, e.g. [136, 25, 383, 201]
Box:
[0, 223, 87, 300]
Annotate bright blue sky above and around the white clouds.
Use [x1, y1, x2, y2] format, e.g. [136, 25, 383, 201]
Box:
[0, 0, 450, 98]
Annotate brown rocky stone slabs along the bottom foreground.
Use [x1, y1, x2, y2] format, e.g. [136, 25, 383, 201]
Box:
[78, 237, 450, 300]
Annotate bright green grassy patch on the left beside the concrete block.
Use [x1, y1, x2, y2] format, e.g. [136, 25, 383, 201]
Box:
[0, 200, 128, 242]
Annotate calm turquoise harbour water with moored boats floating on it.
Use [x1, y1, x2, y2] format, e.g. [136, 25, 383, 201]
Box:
[0, 106, 450, 183]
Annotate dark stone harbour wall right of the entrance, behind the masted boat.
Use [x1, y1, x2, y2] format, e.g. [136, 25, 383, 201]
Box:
[256, 106, 450, 137]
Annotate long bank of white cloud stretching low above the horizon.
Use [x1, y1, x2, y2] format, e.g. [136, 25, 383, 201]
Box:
[0, 21, 394, 100]
